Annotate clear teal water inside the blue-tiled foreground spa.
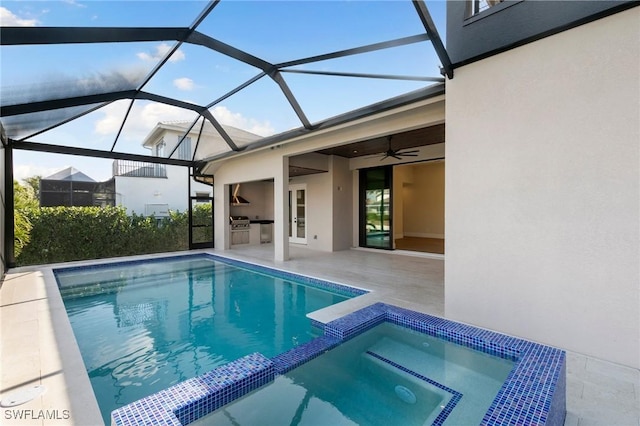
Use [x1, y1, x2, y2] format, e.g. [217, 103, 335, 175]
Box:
[199, 323, 514, 426]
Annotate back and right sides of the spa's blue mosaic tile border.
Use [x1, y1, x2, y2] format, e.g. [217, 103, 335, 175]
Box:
[332, 303, 566, 426]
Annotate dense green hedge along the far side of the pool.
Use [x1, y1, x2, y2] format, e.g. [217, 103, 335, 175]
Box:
[16, 204, 205, 266]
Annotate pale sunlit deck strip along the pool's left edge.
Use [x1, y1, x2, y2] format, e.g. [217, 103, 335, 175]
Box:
[0, 265, 104, 425]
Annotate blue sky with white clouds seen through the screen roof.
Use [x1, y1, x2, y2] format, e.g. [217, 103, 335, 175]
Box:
[0, 0, 445, 181]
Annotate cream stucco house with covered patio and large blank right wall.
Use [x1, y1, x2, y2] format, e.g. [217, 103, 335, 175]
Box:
[204, 0, 640, 368]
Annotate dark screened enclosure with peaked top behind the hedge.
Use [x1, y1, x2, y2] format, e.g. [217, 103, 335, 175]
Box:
[39, 167, 115, 207]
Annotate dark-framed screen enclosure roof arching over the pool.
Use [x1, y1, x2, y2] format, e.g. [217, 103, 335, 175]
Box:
[0, 0, 453, 170]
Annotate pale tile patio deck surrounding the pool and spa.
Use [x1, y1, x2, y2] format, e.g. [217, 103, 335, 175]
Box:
[0, 245, 640, 426]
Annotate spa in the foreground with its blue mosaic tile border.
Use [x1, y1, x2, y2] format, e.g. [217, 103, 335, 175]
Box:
[112, 303, 566, 426]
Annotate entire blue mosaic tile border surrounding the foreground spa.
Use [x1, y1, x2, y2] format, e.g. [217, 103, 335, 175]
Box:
[111, 303, 566, 426]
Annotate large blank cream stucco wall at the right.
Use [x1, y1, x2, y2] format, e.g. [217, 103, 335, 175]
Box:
[445, 7, 640, 368]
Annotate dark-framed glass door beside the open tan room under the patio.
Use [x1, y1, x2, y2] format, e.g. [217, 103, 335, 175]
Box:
[360, 166, 393, 249]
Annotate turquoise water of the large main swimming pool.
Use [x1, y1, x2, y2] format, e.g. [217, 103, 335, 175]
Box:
[55, 257, 349, 424]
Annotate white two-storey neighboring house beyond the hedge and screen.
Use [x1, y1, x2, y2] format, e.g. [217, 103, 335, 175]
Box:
[113, 121, 260, 217]
